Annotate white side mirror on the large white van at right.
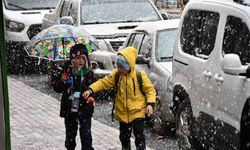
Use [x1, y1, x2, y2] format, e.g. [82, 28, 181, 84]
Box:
[222, 54, 247, 75]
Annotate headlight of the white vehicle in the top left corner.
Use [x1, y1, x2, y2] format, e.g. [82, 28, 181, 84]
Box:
[5, 19, 25, 32]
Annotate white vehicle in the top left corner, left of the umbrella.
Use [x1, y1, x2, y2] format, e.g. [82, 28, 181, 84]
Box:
[2, 0, 59, 71]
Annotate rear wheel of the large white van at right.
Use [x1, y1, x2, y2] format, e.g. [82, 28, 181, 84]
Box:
[176, 100, 194, 150]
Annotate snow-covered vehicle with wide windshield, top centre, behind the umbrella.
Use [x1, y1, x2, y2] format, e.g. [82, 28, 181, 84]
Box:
[42, 0, 167, 52]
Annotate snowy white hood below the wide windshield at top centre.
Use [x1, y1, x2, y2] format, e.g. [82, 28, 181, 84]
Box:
[80, 22, 141, 38]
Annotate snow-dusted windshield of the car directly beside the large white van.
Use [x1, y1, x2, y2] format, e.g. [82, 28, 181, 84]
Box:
[155, 29, 177, 62]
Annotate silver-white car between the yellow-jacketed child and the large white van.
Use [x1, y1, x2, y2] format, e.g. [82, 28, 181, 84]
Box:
[120, 19, 179, 132]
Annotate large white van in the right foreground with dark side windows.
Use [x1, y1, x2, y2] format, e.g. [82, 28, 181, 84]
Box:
[172, 0, 250, 150]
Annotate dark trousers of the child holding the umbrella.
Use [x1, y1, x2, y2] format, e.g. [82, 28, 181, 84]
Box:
[64, 115, 94, 150]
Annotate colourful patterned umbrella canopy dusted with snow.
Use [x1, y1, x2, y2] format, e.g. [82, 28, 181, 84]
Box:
[25, 24, 98, 61]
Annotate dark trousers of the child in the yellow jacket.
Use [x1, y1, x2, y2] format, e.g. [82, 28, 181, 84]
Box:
[120, 118, 146, 150]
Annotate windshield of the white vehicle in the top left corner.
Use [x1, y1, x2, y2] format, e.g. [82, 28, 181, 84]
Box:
[4, 0, 59, 10]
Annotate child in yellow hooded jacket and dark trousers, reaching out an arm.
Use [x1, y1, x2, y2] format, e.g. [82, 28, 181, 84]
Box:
[82, 47, 156, 150]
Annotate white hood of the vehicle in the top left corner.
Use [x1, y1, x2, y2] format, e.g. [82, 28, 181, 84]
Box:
[4, 10, 49, 24]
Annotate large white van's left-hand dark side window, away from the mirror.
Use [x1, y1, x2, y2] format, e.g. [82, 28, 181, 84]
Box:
[181, 10, 219, 59]
